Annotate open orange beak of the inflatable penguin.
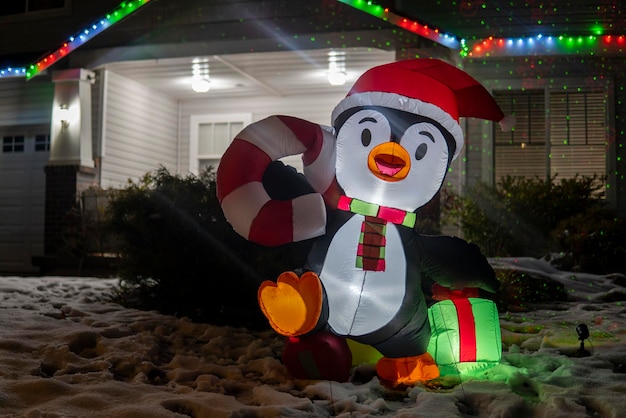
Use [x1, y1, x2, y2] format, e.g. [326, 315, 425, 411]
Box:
[367, 142, 411, 182]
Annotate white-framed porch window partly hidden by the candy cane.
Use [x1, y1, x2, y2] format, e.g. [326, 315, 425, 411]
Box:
[189, 113, 252, 174]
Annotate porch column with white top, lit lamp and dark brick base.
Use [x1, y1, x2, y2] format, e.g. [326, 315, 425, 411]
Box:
[44, 69, 96, 256]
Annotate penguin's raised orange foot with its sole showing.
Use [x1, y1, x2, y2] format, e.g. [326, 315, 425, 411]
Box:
[258, 271, 322, 337]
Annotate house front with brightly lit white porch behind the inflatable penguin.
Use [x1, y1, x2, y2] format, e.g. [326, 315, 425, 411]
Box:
[0, 0, 626, 273]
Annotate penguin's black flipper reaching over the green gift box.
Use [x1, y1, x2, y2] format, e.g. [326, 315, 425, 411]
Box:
[417, 235, 499, 293]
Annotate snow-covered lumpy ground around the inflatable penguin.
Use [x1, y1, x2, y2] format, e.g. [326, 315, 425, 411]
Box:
[0, 259, 626, 418]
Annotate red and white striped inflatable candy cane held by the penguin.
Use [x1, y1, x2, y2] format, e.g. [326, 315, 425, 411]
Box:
[217, 116, 336, 246]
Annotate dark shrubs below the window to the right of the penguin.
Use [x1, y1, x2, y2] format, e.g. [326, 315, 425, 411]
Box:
[444, 176, 624, 272]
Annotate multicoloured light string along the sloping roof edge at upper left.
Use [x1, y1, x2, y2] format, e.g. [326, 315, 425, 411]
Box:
[24, 0, 150, 80]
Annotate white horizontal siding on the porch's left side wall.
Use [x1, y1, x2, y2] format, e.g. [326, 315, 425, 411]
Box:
[100, 72, 178, 188]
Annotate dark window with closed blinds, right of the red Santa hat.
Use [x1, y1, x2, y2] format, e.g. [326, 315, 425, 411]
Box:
[494, 90, 607, 181]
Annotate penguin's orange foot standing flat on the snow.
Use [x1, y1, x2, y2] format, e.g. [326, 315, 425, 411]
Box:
[376, 353, 439, 386]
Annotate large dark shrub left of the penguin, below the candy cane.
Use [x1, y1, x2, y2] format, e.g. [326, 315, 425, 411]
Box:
[107, 168, 314, 327]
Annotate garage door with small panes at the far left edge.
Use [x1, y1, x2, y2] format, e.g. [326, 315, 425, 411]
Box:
[0, 126, 50, 273]
